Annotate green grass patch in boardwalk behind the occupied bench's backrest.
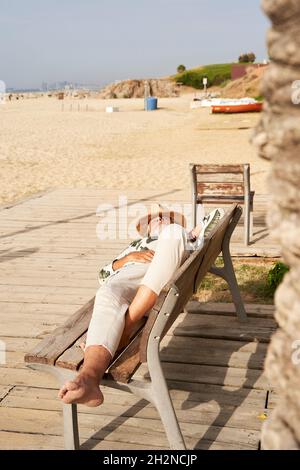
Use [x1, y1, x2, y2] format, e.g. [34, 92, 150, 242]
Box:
[195, 258, 289, 304]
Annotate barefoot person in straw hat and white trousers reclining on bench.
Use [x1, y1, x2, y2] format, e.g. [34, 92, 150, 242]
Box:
[58, 206, 222, 407]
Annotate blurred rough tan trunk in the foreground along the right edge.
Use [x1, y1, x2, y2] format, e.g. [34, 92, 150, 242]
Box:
[253, 0, 300, 450]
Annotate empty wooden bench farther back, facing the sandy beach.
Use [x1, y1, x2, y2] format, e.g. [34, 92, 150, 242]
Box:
[190, 163, 254, 245]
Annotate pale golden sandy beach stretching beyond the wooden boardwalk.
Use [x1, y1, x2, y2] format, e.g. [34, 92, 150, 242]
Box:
[0, 94, 269, 204]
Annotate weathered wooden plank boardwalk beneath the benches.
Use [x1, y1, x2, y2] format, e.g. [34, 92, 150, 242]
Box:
[0, 189, 279, 449]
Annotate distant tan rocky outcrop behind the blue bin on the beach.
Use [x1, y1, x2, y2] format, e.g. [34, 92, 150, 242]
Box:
[99, 79, 179, 99]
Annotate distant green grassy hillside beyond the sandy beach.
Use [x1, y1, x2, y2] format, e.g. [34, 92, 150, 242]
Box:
[174, 64, 232, 89]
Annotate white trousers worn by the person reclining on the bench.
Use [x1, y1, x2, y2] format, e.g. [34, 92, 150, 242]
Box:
[86, 224, 189, 357]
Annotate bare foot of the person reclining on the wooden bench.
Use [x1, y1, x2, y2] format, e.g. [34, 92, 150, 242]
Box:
[58, 373, 103, 407]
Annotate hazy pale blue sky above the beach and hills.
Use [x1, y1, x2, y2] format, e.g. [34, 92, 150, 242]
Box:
[0, 0, 269, 87]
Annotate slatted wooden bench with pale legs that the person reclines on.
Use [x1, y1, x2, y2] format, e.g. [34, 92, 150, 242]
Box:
[25, 205, 247, 449]
